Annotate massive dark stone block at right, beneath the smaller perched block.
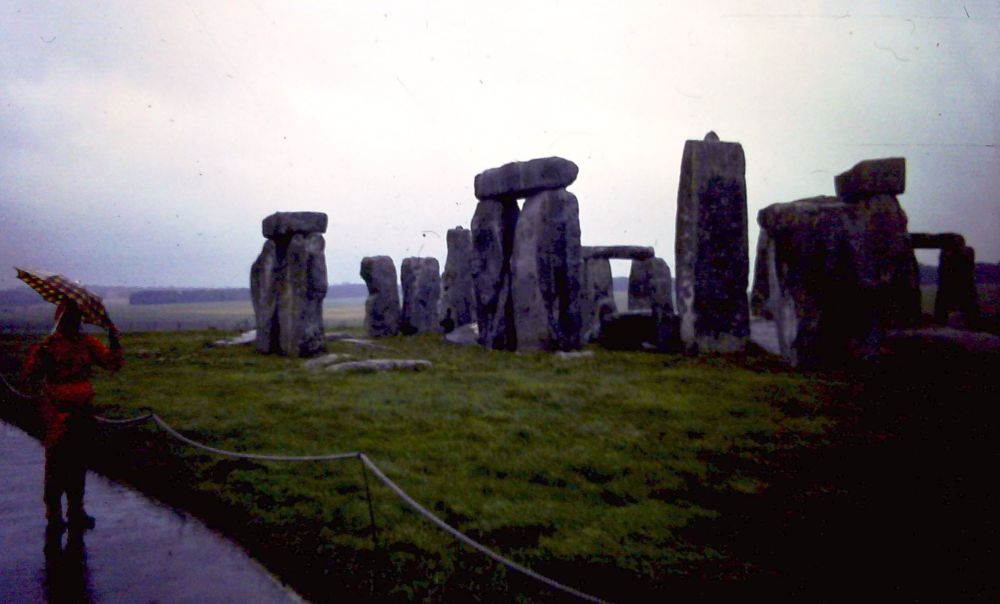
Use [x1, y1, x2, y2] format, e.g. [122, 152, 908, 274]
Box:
[757, 195, 919, 365]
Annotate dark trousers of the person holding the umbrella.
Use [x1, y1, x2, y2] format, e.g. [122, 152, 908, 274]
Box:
[42, 415, 95, 518]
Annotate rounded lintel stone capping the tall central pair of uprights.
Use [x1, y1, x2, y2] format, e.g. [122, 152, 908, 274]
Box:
[475, 157, 580, 200]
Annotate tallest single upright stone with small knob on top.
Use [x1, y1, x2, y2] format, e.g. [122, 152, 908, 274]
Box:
[675, 136, 750, 352]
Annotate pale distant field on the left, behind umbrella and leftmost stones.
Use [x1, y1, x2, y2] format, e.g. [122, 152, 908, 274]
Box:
[0, 298, 365, 332]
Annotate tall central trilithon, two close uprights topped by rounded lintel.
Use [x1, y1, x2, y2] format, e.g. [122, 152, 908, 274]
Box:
[472, 157, 583, 350]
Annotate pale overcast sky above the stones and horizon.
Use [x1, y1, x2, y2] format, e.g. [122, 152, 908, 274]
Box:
[0, 0, 1000, 287]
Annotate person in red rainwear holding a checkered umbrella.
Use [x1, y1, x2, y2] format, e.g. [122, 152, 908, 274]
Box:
[18, 270, 124, 532]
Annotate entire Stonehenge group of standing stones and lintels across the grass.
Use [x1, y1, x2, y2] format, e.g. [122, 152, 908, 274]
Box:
[251, 139, 979, 366]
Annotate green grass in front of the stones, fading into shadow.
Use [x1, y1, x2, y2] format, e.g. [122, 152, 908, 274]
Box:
[4, 332, 843, 599]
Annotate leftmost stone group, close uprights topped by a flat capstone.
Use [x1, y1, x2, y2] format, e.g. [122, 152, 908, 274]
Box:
[250, 212, 328, 357]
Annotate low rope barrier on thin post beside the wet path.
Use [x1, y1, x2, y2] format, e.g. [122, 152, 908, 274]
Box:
[0, 374, 607, 604]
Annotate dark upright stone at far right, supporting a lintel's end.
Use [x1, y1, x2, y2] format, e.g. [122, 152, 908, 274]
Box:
[934, 246, 979, 327]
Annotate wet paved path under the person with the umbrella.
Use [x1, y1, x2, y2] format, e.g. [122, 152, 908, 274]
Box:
[0, 421, 301, 603]
